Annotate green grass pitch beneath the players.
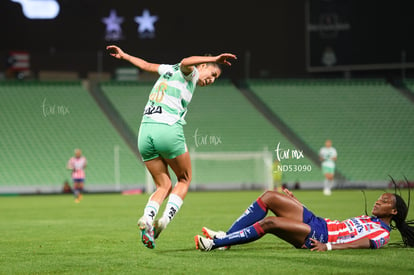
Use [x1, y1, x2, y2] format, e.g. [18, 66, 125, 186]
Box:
[0, 190, 414, 274]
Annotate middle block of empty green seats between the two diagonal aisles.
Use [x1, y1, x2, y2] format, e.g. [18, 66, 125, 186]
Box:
[101, 80, 321, 188]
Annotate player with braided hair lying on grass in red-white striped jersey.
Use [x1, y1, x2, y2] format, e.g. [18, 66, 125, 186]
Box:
[194, 189, 414, 251]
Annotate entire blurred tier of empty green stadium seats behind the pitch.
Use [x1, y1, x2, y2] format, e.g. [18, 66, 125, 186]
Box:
[0, 79, 414, 193]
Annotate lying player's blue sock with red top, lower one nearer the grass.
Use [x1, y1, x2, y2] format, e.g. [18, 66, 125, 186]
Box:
[213, 222, 265, 248]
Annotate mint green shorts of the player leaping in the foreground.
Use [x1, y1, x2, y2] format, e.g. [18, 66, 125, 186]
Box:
[138, 122, 187, 161]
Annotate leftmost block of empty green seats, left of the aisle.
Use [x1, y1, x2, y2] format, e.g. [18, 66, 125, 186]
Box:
[0, 82, 145, 192]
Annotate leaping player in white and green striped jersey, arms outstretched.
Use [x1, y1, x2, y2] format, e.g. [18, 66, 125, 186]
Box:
[107, 45, 236, 248]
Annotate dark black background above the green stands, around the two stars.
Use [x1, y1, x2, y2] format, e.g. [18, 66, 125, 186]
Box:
[0, 0, 414, 78]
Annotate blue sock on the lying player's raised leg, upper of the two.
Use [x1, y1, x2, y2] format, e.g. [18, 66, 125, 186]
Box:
[226, 197, 267, 234]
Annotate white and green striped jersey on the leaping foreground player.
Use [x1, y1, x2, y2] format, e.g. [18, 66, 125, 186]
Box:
[142, 64, 199, 125]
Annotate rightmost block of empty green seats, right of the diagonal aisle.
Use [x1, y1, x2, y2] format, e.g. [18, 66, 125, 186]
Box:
[249, 80, 414, 182]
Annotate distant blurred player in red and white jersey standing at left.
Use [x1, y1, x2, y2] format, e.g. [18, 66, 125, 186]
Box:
[67, 149, 87, 203]
